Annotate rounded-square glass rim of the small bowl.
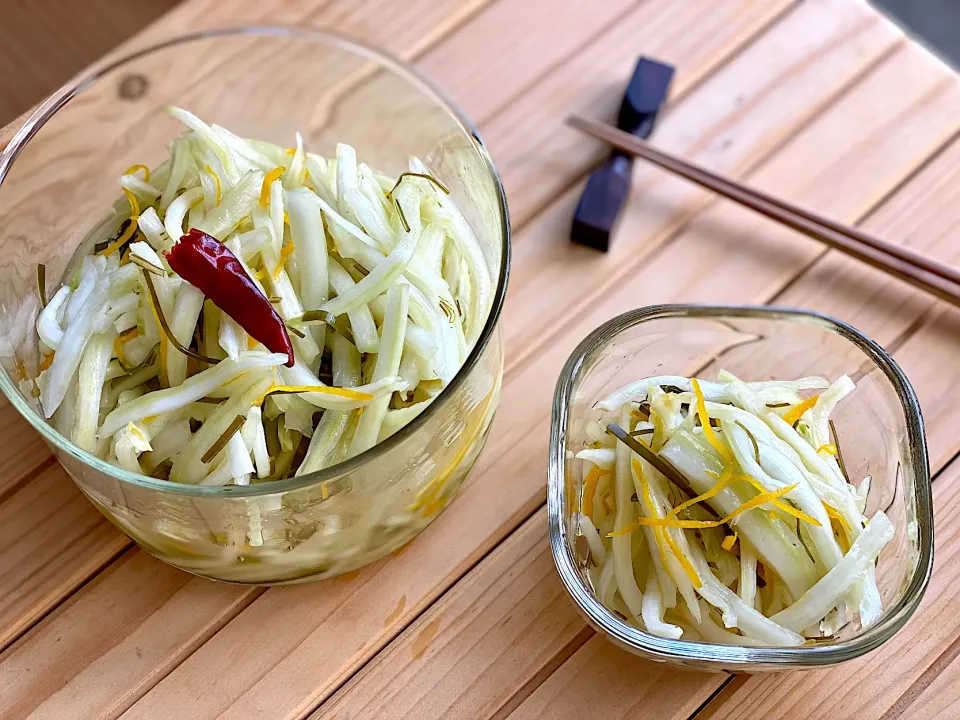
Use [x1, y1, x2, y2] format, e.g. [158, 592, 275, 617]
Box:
[547, 304, 933, 671]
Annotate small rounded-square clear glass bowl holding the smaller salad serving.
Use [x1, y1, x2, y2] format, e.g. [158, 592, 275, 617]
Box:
[547, 305, 933, 672]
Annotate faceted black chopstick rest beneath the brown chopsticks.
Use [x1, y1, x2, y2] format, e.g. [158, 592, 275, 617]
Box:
[570, 57, 674, 252]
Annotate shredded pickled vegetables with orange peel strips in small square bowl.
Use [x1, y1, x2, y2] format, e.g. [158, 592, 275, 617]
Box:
[576, 372, 894, 646]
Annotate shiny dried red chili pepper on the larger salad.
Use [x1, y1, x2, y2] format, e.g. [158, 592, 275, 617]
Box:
[165, 228, 293, 367]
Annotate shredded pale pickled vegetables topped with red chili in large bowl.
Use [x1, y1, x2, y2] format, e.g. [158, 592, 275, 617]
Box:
[36, 108, 491, 485]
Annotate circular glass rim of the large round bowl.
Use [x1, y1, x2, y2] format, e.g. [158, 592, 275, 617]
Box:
[0, 25, 510, 498]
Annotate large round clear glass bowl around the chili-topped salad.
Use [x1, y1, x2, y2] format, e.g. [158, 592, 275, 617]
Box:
[0, 28, 509, 584]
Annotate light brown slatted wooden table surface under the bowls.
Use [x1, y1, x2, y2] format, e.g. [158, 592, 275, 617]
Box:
[0, 0, 960, 720]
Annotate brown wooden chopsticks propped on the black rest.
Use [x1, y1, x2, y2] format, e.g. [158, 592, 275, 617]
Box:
[567, 116, 960, 307]
